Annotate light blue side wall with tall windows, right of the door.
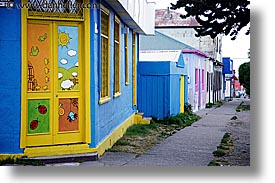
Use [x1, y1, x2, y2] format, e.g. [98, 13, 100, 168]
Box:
[90, 3, 138, 147]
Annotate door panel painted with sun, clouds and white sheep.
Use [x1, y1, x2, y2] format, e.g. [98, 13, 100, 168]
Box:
[58, 26, 79, 90]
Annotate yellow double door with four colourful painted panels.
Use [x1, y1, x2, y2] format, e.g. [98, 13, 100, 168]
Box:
[23, 21, 84, 146]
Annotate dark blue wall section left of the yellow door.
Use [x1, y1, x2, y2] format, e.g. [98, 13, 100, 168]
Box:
[0, 0, 22, 154]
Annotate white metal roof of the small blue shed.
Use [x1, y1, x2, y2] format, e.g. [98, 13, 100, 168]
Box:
[139, 50, 181, 62]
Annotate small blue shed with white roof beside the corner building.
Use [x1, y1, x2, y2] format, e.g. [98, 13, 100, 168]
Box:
[138, 50, 188, 118]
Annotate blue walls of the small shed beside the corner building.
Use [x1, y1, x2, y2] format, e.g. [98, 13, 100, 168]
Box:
[138, 57, 188, 119]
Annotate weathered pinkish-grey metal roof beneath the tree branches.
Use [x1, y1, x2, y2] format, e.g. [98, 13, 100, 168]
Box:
[155, 8, 201, 28]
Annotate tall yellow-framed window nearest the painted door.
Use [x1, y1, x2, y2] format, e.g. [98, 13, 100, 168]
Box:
[99, 4, 111, 104]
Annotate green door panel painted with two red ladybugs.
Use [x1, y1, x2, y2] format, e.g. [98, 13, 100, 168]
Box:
[28, 99, 50, 134]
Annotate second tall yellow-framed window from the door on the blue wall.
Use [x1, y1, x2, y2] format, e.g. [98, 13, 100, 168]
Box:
[114, 16, 121, 97]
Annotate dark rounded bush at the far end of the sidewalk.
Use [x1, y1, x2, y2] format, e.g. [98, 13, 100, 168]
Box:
[239, 62, 250, 96]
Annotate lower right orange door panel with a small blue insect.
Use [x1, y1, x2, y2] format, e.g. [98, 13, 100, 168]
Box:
[58, 98, 79, 132]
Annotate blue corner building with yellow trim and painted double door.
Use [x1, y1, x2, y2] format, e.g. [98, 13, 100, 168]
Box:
[0, 0, 155, 159]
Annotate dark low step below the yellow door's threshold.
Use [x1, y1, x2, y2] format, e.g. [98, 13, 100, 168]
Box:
[18, 153, 98, 164]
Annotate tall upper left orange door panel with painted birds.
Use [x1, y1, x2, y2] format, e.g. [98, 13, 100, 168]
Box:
[27, 24, 50, 92]
